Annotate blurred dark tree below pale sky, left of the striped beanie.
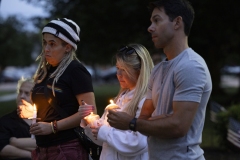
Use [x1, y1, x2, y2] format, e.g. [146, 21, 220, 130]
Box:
[0, 16, 36, 69]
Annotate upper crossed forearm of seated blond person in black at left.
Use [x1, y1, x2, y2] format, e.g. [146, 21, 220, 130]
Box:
[10, 137, 37, 151]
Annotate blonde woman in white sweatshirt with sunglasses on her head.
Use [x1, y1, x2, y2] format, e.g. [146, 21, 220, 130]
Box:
[92, 44, 153, 160]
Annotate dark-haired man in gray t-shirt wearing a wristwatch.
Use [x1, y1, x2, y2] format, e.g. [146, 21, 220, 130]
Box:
[108, 0, 212, 160]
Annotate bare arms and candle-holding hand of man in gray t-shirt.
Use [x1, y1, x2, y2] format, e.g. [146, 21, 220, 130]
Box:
[108, 102, 199, 138]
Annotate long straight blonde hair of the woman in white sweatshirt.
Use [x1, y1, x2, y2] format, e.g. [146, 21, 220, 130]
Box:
[115, 44, 154, 116]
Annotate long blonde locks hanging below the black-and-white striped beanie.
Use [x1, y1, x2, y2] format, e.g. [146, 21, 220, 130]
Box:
[33, 40, 80, 96]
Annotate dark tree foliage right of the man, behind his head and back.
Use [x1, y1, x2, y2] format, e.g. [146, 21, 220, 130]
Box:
[189, 0, 240, 105]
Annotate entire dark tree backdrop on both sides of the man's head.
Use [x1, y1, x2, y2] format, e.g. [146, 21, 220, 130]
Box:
[18, 0, 240, 103]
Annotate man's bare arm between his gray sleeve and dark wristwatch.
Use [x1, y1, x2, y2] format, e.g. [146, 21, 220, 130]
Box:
[136, 102, 199, 138]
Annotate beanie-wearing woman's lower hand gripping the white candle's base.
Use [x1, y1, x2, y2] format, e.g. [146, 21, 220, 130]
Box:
[30, 122, 53, 135]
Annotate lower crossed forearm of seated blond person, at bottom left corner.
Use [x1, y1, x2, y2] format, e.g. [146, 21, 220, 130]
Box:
[0, 145, 31, 159]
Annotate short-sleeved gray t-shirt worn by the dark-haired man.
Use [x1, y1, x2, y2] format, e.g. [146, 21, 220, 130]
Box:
[147, 48, 212, 160]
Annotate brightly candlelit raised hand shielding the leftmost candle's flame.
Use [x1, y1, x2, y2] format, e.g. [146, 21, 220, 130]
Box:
[17, 99, 33, 118]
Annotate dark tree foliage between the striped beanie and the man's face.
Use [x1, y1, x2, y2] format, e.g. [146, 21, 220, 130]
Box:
[44, 0, 152, 65]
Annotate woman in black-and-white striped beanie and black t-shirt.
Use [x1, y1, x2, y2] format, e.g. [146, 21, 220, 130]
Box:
[26, 18, 95, 160]
